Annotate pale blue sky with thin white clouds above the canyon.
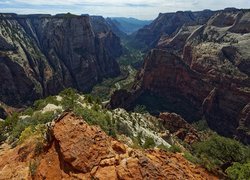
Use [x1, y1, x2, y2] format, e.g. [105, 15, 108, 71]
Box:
[0, 0, 250, 20]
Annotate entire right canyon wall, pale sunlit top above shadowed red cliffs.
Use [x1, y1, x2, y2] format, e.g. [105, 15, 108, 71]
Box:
[110, 9, 250, 143]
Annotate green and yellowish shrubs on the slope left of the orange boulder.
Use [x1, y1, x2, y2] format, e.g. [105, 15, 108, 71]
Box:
[0, 90, 68, 143]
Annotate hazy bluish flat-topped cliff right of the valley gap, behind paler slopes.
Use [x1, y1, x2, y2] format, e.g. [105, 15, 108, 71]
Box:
[135, 10, 214, 47]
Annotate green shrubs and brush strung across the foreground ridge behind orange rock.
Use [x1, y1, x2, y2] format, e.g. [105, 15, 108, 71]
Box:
[0, 89, 250, 179]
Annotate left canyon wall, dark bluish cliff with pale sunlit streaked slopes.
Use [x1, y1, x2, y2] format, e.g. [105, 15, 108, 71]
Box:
[0, 14, 122, 105]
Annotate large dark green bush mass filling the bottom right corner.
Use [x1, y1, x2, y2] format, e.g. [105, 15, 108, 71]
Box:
[188, 135, 250, 176]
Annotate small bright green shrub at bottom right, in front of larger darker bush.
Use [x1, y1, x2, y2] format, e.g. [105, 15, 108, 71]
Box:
[226, 161, 250, 180]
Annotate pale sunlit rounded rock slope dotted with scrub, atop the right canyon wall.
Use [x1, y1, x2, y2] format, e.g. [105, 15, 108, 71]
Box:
[183, 10, 250, 79]
